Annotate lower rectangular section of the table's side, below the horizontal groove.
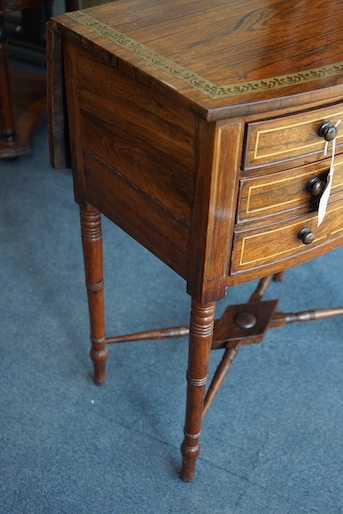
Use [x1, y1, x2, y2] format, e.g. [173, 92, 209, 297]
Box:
[84, 152, 189, 278]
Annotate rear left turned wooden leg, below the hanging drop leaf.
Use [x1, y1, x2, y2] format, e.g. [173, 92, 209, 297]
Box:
[80, 206, 108, 385]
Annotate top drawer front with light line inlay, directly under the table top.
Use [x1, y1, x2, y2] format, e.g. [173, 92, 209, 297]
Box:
[243, 105, 343, 169]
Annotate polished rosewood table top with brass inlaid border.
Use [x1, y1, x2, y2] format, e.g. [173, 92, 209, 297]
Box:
[51, 0, 343, 118]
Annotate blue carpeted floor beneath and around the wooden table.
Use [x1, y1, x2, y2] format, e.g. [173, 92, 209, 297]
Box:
[0, 122, 343, 514]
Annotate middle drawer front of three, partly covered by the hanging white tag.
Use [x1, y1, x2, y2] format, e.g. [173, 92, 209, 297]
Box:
[237, 156, 343, 222]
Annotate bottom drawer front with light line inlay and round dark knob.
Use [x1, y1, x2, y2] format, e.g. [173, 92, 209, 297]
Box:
[231, 202, 343, 273]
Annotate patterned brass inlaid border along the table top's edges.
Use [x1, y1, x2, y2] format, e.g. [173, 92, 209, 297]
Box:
[66, 11, 343, 100]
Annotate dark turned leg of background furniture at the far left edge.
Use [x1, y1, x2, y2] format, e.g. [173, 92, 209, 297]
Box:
[0, 16, 16, 142]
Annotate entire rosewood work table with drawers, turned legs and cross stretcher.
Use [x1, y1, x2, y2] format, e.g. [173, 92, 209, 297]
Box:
[47, 0, 343, 480]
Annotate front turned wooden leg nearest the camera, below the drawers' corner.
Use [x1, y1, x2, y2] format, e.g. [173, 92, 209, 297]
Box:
[181, 301, 215, 481]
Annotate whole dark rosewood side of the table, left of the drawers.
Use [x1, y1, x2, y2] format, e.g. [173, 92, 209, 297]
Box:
[65, 41, 196, 278]
